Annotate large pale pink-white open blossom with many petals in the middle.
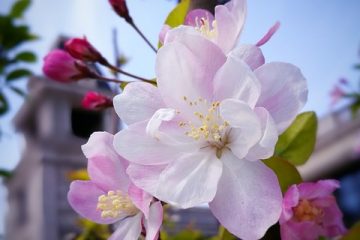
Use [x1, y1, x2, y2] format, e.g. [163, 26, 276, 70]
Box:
[114, 34, 307, 239]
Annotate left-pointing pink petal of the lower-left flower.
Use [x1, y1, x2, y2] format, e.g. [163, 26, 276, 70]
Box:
[67, 181, 119, 224]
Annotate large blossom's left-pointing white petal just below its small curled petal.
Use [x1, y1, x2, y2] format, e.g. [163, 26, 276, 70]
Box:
[114, 122, 190, 165]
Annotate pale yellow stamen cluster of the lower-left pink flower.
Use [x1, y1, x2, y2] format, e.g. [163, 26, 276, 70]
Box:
[97, 191, 139, 218]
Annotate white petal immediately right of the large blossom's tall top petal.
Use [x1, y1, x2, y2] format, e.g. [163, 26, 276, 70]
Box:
[214, 54, 261, 107]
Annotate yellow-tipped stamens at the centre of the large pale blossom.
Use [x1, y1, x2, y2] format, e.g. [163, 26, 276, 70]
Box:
[179, 96, 229, 151]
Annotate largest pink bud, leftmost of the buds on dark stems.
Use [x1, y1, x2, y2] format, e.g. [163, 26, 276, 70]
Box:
[43, 49, 93, 83]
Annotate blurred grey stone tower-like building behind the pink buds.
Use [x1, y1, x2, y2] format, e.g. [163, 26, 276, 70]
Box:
[5, 77, 119, 240]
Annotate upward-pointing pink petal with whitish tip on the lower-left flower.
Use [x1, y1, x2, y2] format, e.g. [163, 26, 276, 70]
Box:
[82, 132, 129, 192]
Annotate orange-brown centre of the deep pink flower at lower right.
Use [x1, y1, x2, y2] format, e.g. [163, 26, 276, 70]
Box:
[293, 199, 324, 223]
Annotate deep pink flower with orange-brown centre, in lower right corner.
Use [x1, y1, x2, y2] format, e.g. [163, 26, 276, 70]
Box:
[280, 180, 346, 240]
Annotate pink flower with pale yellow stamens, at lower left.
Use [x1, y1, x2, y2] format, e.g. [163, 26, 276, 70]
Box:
[68, 132, 163, 240]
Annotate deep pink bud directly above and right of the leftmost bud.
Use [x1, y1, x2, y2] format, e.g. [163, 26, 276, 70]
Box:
[65, 38, 105, 62]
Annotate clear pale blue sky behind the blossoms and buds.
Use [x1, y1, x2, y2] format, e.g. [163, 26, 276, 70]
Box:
[0, 0, 360, 233]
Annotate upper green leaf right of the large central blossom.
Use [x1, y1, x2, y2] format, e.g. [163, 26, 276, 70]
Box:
[275, 112, 317, 165]
